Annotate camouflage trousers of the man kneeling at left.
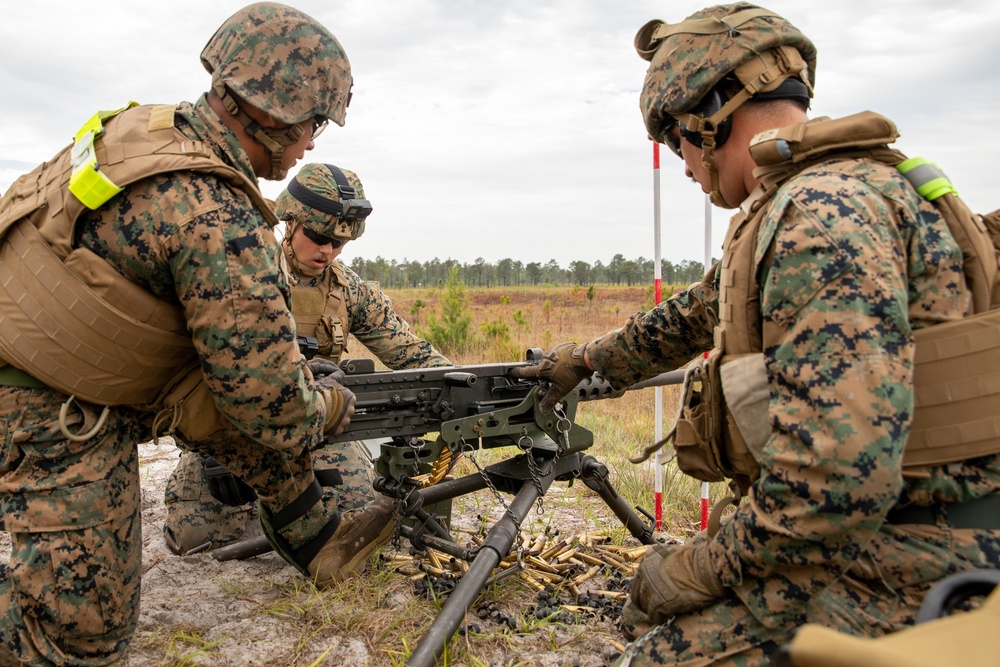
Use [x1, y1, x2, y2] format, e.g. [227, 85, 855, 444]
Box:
[0, 386, 338, 667]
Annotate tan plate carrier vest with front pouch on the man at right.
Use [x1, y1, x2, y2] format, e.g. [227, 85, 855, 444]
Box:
[648, 112, 1000, 506]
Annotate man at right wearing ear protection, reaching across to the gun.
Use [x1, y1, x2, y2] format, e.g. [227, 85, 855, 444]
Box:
[518, 3, 1000, 665]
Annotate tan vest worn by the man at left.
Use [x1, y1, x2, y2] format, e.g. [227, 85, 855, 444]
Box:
[0, 105, 277, 406]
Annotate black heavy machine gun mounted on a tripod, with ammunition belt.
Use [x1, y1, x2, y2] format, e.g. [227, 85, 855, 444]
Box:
[214, 349, 677, 667]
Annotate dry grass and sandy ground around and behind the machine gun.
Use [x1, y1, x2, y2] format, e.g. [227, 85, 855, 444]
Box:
[0, 286, 721, 667]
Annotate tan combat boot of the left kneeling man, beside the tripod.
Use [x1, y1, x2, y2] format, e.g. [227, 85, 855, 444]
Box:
[307, 496, 394, 587]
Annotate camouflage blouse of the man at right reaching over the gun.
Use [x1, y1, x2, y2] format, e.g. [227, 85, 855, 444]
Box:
[588, 160, 1000, 627]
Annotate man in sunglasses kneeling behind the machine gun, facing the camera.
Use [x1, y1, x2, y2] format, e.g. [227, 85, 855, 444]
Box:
[163, 163, 451, 554]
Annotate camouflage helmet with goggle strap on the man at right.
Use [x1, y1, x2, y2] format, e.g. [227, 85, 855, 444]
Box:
[635, 2, 816, 205]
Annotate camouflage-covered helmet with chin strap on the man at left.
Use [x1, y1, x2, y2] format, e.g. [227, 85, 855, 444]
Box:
[201, 2, 353, 180]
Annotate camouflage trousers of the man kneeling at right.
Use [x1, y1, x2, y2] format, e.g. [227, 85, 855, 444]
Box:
[616, 524, 1000, 667]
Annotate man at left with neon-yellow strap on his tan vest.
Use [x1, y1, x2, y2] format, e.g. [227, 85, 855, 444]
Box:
[0, 3, 392, 665]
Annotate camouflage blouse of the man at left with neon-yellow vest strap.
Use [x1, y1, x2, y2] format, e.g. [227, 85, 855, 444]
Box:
[77, 96, 325, 449]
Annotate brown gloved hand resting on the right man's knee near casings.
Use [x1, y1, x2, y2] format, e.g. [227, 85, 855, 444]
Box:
[628, 539, 726, 625]
